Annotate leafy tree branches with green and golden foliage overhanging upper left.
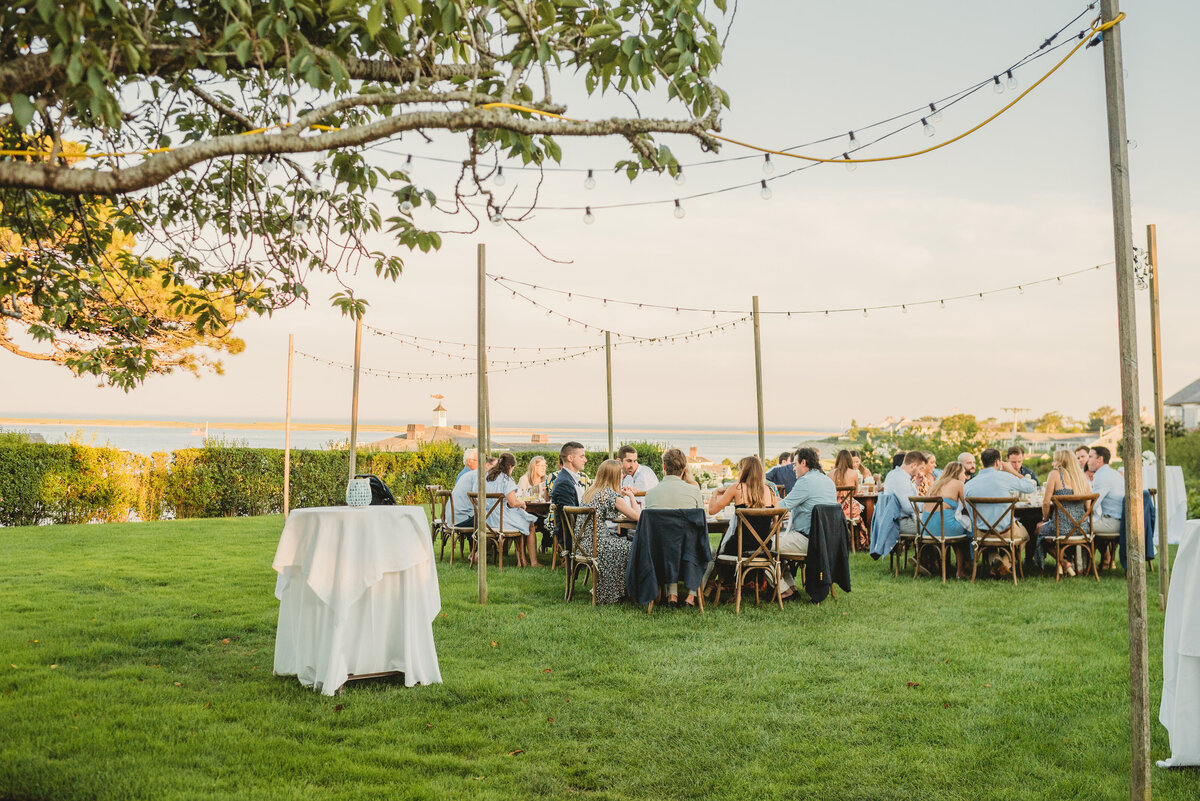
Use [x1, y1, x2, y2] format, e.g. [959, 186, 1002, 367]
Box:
[0, 0, 728, 385]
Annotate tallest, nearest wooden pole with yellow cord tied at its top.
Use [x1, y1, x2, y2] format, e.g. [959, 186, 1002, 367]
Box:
[1100, 0, 1150, 801]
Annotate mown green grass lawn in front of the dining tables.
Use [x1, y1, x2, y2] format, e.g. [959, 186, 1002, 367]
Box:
[0, 517, 1200, 801]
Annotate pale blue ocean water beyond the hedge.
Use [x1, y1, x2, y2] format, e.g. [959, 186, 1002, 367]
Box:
[2, 415, 834, 462]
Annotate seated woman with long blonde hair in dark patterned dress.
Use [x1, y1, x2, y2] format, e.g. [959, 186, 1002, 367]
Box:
[576, 459, 642, 603]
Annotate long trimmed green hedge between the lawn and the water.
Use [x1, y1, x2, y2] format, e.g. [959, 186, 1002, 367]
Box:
[0, 436, 664, 526]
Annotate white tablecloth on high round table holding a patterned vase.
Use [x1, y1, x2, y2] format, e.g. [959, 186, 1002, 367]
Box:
[271, 506, 442, 695]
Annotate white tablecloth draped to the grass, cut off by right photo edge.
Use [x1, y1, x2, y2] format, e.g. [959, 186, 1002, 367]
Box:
[1158, 520, 1200, 767]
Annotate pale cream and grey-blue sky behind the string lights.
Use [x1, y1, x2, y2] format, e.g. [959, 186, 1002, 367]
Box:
[0, 0, 1200, 429]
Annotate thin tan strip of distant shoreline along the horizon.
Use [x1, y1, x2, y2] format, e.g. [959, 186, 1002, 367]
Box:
[0, 417, 838, 436]
